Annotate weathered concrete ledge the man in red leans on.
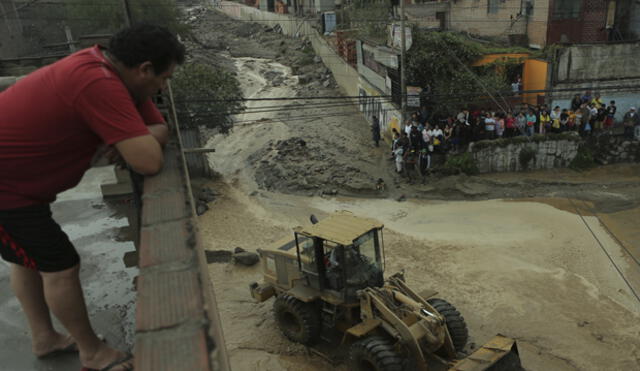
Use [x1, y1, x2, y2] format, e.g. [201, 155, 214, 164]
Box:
[134, 138, 229, 371]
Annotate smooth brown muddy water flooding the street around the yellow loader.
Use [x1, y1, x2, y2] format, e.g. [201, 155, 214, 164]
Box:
[201, 183, 640, 370]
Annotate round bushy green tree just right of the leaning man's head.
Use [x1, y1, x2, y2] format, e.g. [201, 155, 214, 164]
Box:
[171, 63, 244, 133]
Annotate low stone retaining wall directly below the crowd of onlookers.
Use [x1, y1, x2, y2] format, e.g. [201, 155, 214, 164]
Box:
[469, 135, 580, 173]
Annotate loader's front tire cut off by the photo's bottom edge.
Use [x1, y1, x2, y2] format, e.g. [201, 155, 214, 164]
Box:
[349, 336, 404, 371]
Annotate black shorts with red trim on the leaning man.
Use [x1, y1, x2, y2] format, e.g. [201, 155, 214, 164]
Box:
[0, 204, 80, 272]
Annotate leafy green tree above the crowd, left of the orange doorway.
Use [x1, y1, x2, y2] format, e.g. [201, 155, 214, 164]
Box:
[406, 30, 508, 114]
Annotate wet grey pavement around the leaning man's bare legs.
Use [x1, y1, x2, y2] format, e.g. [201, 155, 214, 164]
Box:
[0, 167, 137, 371]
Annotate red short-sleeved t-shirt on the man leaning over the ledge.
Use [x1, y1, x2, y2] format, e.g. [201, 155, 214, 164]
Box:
[0, 46, 164, 210]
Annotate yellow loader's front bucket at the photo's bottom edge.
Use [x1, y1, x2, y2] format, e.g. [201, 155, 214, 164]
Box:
[449, 335, 524, 371]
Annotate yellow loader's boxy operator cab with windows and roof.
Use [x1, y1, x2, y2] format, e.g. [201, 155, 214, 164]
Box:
[295, 215, 384, 302]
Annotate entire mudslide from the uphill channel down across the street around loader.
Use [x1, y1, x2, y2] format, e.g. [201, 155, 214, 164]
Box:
[181, 5, 640, 371]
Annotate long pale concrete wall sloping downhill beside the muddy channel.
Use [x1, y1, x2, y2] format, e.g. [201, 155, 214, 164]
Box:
[216, 1, 400, 132]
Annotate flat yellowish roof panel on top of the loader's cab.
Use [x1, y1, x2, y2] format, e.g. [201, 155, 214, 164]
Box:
[298, 213, 384, 245]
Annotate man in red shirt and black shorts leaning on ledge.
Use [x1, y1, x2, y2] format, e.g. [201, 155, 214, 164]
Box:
[0, 25, 185, 371]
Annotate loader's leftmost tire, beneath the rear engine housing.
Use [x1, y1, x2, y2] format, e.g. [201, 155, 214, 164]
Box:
[273, 294, 321, 345]
